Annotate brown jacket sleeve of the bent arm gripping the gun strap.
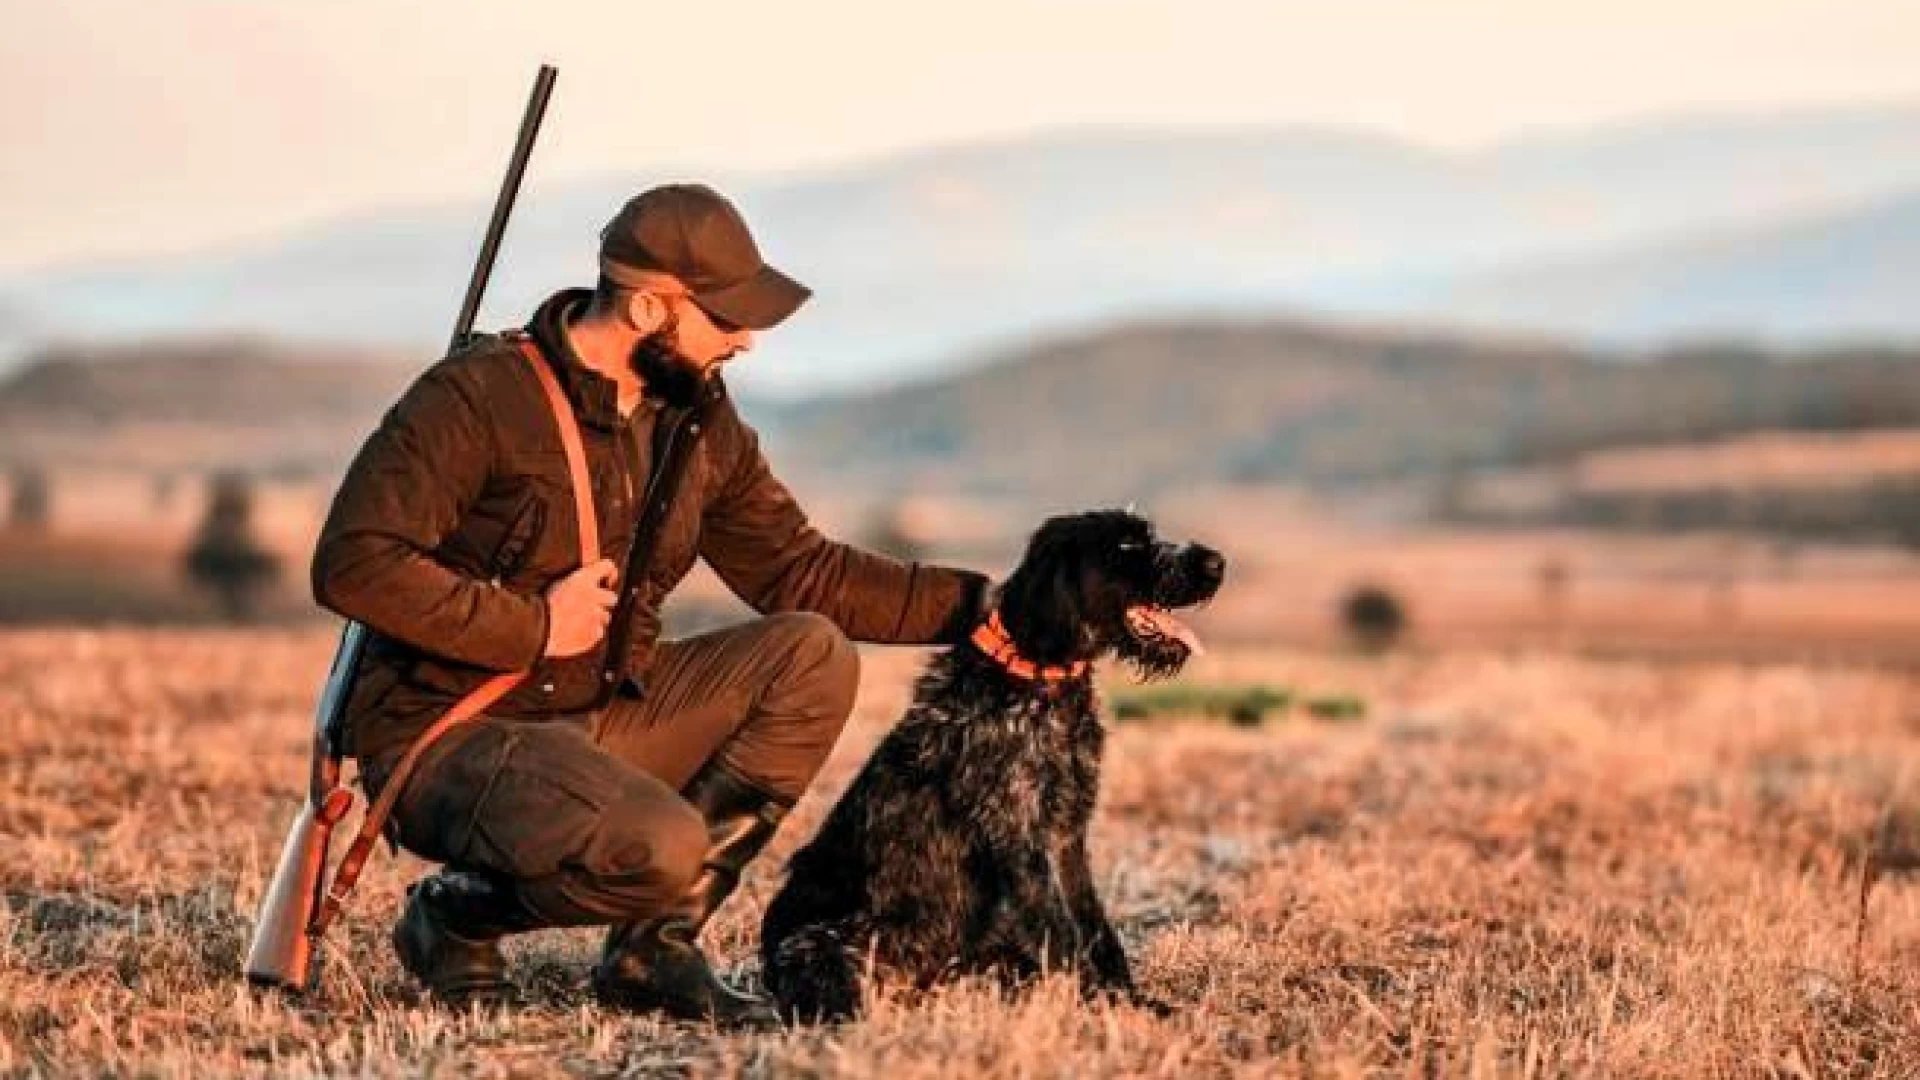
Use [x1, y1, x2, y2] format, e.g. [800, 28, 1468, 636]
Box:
[313, 363, 547, 671]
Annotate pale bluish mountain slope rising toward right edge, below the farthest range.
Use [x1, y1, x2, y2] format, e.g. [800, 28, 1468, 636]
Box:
[1405, 194, 1920, 342]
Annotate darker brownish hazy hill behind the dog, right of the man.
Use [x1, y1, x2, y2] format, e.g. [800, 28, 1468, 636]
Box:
[770, 321, 1920, 503]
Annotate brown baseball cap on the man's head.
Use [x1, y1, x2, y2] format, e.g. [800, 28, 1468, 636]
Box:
[601, 184, 812, 331]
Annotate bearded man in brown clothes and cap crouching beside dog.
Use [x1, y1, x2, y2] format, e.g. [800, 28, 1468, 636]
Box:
[313, 184, 987, 1024]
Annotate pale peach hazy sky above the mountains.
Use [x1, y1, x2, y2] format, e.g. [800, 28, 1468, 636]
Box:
[0, 0, 1920, 271]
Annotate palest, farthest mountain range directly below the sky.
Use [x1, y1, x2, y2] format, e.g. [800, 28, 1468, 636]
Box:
[11, 99, 1920, 394]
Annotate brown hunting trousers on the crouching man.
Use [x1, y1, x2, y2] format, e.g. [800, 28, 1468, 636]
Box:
[369, 613, 860, 926]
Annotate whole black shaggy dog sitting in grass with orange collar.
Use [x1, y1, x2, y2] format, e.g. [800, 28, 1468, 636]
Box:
[760, 511, 1225, 1020]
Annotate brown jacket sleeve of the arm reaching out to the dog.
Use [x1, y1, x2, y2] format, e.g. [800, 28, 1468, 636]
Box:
[701, 404, 987, 644]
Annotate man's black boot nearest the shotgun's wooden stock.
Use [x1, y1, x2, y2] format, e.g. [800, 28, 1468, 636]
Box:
[394, 869, 538, 1007]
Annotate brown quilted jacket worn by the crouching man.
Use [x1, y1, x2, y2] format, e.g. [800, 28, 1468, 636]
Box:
[313, 290, 987, 761]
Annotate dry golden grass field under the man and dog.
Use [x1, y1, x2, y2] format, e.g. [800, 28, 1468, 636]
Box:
[0, 628, 1920, 1080]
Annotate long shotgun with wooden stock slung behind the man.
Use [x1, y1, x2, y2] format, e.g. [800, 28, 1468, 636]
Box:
[246, 63, 557, 992]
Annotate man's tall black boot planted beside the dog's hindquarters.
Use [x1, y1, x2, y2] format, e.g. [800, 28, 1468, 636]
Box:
[593, 763, 787, 1028]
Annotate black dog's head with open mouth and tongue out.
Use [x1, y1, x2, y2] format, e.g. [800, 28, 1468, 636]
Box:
[1000, 509, 1227, 676]
